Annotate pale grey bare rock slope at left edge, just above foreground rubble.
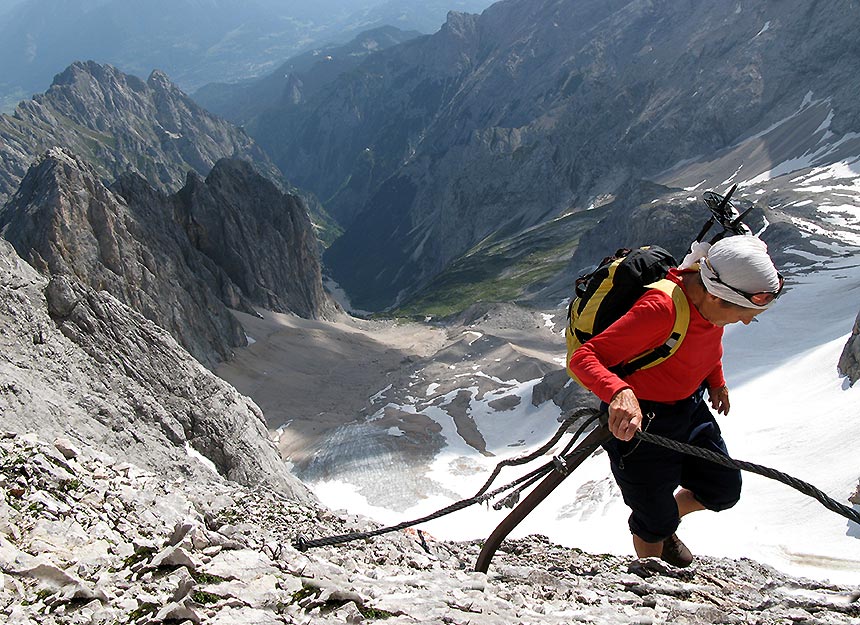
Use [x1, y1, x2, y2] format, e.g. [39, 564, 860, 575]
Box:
[0, 239, 307, 497]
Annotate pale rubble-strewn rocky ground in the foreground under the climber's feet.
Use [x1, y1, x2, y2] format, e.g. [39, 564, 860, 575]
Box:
[0, 433, 860, 625]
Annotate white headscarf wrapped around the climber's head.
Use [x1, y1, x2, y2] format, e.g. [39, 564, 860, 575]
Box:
[681, 235, 779, 310]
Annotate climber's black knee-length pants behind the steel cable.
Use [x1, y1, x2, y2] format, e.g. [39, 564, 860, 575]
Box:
[603, 386, 741, 542]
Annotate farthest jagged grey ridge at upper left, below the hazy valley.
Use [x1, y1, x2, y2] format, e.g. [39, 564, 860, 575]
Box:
[0, 61, 281, 203]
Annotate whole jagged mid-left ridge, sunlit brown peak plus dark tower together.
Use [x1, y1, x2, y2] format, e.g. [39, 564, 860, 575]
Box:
[0, 149, 324, 364]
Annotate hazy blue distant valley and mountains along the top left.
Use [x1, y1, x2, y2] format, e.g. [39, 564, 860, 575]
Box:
[0, 0, 492, 110]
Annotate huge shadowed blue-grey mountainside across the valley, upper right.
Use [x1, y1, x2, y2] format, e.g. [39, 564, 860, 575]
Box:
[242, 0, 860, 309]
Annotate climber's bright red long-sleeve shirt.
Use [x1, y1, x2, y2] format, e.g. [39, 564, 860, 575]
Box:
[570, 269, 725, 403]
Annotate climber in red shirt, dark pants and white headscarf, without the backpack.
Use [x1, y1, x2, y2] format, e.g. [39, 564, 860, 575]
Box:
[569, 236, 784, 567]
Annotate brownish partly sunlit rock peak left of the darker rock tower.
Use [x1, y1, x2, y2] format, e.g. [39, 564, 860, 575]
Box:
[0, 149, 245, 362]
